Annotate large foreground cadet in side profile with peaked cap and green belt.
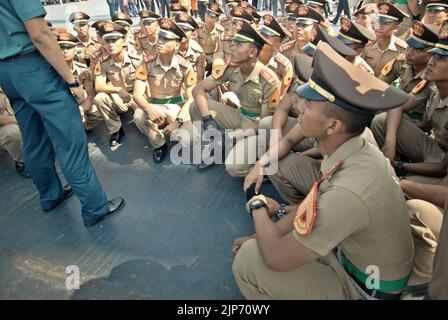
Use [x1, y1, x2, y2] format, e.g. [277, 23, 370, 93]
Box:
[233, 43, 414, 300]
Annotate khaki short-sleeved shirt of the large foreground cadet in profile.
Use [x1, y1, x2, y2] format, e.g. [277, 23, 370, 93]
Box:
[293, 136, 414, 280]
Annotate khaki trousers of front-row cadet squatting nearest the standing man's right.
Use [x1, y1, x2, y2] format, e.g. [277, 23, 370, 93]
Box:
[134, 104, 198, 148]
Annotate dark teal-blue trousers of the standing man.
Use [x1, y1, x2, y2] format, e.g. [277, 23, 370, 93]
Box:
[0, 52, 108, 222]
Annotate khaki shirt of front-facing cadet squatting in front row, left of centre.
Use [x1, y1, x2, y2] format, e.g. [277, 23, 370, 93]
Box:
[137, 55, 196, 99]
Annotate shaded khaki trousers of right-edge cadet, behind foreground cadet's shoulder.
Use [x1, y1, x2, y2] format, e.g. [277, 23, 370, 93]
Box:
[370, 112, 445, 184]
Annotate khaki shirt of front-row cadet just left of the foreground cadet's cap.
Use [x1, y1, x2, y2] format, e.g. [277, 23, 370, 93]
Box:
[212, 61, 280, 117]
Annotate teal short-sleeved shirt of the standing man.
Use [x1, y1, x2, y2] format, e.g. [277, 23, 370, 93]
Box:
[0, 0, 47, 59]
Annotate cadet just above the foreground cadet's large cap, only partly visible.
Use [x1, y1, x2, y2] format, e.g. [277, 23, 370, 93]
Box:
[337, 17, 376, 75]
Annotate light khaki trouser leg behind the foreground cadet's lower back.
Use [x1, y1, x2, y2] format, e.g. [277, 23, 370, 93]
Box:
[407, 199, 443, 285]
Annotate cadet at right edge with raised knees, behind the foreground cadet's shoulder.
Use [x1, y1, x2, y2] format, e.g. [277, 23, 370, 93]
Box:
[371, 22, 448, 183]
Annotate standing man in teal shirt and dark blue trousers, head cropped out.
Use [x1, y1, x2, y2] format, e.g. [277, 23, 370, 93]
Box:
[0, 0, 124, 226]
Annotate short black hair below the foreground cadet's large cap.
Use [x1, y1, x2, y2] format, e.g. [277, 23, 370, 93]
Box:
[324, 102, 375, 136]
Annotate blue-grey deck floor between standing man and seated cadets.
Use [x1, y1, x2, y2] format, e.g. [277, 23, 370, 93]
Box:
[0, 116, 280, 299]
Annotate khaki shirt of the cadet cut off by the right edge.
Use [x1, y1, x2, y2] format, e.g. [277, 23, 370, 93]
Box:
[425, 85, 448, 151]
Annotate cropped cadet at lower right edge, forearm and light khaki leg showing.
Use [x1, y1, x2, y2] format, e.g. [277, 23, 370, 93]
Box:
[400, 175, 448, 299]
